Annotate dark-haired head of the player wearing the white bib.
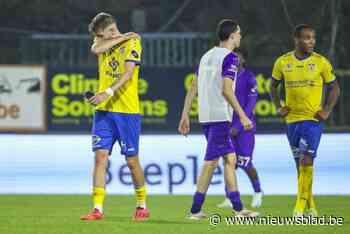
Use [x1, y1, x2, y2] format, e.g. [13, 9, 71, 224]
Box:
[216, 19, 241, 48]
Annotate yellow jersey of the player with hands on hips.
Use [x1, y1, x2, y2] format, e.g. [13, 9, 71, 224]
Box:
[272, 51, 335, 123]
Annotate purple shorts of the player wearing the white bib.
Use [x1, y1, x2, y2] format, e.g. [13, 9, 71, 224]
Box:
[202, 122, 235, 161]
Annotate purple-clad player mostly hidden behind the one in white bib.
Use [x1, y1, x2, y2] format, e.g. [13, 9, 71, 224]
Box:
[218, 49, 263, 208]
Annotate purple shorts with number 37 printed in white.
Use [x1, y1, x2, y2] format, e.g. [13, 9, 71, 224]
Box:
[232, 130, 255, 169]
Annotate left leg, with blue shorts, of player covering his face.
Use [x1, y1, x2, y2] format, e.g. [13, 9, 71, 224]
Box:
[81, 111, 115, 220]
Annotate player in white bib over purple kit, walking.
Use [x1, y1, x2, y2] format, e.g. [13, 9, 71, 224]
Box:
[178, 19, 258, 220]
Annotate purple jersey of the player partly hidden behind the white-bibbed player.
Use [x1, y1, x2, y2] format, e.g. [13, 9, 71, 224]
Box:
[232, 69, 258, 132]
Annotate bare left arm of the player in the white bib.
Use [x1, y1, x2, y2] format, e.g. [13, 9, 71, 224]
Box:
[178, 76, 197, 136]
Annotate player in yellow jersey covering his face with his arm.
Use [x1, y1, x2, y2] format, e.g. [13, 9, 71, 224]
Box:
[81, 12, 149, 221]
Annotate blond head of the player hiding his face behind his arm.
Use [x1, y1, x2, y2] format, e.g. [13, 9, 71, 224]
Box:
[89, 12, 120, 39]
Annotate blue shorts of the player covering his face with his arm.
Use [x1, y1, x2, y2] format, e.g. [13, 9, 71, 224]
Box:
[92, 111, 141, 156]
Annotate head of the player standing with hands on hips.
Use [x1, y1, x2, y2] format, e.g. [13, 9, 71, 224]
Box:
[294, 24, 316, 53]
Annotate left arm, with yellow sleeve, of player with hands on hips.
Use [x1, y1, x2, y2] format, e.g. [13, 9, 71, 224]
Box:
[270, 59, 290, 117]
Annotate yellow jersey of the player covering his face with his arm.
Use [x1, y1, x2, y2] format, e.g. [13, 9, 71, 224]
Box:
[96, 38, 142, 114]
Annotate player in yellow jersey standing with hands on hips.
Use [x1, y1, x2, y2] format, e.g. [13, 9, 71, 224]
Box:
[271, 24, 340, 216]
